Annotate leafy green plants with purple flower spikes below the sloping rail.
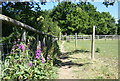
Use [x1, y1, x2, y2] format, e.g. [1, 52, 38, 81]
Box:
[2, 39, 56, 79]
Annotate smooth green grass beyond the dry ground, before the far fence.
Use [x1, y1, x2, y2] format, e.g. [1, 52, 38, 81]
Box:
[64, 40, 118, 57]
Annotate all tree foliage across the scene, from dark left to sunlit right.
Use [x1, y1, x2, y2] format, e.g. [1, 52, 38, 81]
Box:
[2, 2, 117, 36]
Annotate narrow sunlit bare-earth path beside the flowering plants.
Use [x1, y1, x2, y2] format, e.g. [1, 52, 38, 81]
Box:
[58, 41, 74, 79]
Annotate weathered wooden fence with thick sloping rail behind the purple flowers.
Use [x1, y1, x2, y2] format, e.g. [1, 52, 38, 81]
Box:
[0, 14, 60, 64]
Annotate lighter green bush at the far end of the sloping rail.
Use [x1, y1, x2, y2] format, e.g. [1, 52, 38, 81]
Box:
[37, 11, 60, 36]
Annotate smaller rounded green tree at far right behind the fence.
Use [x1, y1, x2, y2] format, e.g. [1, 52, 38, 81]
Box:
[96, 12, 117, 35]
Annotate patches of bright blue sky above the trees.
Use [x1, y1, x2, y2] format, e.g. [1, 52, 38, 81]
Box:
[41, 2, 118, 21]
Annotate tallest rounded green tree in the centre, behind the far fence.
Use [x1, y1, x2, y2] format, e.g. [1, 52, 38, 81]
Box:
[51, 2, 88, 34]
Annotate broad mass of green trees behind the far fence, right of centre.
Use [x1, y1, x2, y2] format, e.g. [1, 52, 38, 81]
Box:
[51, 2, 117, 34]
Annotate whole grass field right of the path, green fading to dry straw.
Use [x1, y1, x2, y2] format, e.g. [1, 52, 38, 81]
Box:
[58, 40, 118, 79]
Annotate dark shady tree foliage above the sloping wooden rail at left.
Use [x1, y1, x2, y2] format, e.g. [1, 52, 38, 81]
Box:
[2, 2, 59, 36]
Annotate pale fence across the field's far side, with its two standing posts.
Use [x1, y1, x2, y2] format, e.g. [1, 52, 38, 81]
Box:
[59, 26, 120, 59]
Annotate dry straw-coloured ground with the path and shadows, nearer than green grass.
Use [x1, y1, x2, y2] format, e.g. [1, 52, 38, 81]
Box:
[58, 41, 118, 79]
